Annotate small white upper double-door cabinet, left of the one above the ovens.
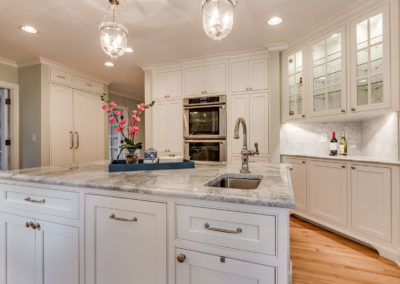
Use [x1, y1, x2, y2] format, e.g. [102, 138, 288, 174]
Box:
[153, 71, 182, 100]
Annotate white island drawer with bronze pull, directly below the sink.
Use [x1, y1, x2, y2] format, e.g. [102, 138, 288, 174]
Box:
[177, 205, 277, 256]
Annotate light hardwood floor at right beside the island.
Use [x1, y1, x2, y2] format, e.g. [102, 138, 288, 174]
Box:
[290, 216, 400, 284]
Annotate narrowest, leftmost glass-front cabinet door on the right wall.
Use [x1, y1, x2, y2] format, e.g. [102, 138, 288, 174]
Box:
[287, 50, 305, 119]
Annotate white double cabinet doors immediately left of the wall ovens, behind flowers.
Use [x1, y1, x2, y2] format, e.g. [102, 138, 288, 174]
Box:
[153, 100, 183, 154]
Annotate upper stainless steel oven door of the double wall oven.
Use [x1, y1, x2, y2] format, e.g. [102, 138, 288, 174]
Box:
[183, 104, 226, 139]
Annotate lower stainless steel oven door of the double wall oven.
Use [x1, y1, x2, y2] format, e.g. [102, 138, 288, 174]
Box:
[185, 140, 226, 162]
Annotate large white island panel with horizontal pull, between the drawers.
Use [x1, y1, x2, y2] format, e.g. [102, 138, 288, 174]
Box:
[85, 196, 167, 284]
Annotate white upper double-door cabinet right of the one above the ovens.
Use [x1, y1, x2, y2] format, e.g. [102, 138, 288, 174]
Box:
[230, 58, 268, 93]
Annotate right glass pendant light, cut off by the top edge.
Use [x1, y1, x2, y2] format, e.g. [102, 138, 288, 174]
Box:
[202, 0, 237, 40]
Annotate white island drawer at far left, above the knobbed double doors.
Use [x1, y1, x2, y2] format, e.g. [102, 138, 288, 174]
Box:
[0, 184, 79, 219]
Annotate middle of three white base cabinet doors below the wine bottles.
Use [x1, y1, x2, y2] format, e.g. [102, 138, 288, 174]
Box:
[307, 161, 347, 226]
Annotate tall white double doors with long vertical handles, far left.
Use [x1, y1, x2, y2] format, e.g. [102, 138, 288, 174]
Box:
[49, 84, 104, 166]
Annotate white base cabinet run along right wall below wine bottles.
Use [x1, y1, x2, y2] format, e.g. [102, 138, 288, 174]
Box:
[283, 156, 400, 263]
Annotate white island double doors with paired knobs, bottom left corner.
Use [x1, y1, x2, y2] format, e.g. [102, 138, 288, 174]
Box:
[0, 214, 79, 284]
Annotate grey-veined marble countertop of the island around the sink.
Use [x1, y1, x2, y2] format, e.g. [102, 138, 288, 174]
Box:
[0, 161, 295, 208]
